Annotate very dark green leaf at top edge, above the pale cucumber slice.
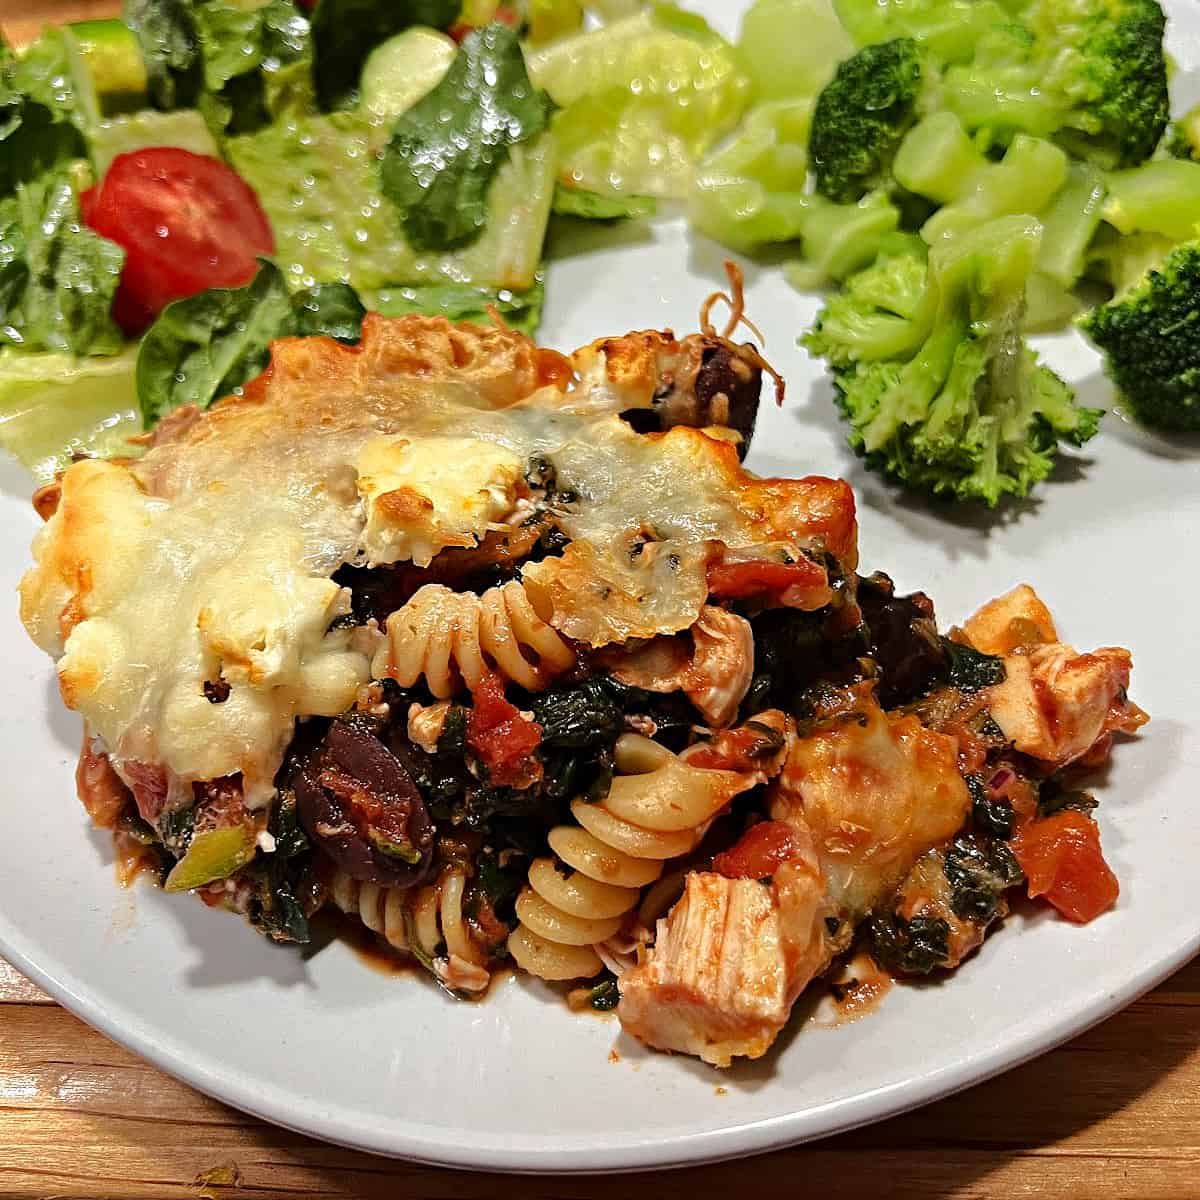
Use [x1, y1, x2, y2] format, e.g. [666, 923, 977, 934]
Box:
[312, 0, 462, 113]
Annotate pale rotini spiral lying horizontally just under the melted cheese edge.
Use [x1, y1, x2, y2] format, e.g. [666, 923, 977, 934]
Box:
[372, 580, 575, 700]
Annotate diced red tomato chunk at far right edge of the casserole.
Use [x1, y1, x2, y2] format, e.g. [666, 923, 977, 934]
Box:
[1012, 809, 1121, 925]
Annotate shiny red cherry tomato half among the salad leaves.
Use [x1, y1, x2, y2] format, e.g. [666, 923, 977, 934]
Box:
[80, 146, 275, 335]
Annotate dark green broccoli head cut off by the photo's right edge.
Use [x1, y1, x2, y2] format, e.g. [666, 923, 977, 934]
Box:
[1080, 241, 1200, 430]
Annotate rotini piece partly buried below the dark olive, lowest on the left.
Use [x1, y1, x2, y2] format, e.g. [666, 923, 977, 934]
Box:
[329, 868, 491, 992]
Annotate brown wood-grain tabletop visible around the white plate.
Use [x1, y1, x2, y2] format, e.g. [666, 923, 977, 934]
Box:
[0, 0, 1200, 1200]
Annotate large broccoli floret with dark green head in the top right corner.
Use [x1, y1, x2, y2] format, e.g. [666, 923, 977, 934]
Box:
[943, 0, 1170, 168]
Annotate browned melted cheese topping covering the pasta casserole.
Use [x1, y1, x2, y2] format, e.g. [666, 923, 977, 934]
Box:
[20, 316, 854, 806]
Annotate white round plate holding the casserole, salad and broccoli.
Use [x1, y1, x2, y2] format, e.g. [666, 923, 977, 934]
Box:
[0, 0, 1200, 1171]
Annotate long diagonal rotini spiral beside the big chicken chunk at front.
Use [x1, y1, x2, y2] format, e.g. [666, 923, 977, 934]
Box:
[508, 733, 752, 979]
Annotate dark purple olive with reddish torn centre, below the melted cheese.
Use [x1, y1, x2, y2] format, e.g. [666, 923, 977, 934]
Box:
[294, 721, 433, 888]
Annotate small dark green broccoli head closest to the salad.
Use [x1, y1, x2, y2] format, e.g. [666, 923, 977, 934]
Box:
[809, 37, 922, 204]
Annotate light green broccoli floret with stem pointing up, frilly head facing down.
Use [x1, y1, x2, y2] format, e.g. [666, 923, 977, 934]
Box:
[804, 216, 1103, 505]
